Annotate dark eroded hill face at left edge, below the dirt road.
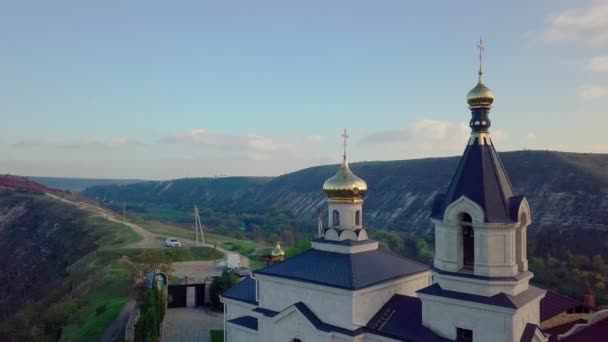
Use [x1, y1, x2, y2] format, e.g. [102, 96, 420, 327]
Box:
[0, 192, 96, 321]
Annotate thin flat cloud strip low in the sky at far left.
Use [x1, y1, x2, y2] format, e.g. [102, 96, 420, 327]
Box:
[12, 137, 144, 150]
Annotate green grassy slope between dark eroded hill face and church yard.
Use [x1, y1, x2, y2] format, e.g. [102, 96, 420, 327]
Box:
[0, 196, 232, 341]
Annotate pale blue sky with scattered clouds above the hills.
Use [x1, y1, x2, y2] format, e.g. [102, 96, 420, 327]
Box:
[0, 0, 608, 179]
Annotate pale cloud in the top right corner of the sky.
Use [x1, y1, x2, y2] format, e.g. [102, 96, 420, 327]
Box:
[541, 0, 608, 46]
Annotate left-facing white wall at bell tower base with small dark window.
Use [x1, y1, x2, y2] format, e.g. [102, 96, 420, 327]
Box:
[420, 295, 521, 342]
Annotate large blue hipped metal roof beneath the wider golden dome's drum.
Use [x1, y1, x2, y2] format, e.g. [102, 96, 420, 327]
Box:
[254, 249, 429, 290]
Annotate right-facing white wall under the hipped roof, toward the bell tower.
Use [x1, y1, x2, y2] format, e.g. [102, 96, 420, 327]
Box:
[353, 271, 432, 326]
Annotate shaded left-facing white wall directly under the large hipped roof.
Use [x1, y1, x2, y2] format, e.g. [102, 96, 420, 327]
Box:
[256, 274, 353, 329]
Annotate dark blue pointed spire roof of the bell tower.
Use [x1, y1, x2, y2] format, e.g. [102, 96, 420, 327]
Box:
[431, 81, 523, 222]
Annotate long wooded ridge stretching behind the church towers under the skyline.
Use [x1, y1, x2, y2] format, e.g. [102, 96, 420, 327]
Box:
[84, 151, 608, 253]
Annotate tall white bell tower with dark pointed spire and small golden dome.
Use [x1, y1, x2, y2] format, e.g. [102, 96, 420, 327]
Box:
[418, 40, 545, 341]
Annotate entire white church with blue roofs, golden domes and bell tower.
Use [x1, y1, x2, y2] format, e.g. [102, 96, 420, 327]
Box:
[222, 45, 547, 342]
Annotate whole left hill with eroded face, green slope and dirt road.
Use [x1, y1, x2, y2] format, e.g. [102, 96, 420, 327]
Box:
[0, 184, 269, 341]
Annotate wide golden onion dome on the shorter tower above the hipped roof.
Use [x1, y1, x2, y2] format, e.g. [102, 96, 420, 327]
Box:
[323, 158, 367, 199]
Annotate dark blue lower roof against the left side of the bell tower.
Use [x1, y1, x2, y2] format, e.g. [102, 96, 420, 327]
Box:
[366, 294, 441, 342]
